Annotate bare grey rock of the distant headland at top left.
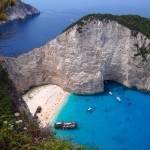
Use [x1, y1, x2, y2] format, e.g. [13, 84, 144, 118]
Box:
[6, 0, 40, 21]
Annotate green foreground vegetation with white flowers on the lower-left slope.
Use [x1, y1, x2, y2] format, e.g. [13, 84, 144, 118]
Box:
[0, 65, 92, 150]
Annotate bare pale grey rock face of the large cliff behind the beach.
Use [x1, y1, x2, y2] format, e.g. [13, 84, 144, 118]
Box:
[0, 17, 150, 94]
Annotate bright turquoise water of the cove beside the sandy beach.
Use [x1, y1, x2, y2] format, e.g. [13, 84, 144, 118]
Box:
[55, 82, 150, 150]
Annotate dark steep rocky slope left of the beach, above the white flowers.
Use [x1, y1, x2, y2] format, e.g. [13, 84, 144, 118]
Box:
[0, 64, 33, 121]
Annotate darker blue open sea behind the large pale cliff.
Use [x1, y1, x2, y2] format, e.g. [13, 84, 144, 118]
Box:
[0, 0, 150, 56]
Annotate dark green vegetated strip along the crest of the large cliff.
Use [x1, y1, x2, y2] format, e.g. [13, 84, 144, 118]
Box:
[64, 14, 150, 38]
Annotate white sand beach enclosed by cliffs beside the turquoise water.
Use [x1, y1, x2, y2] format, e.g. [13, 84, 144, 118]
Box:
[23, 85, 68, 127]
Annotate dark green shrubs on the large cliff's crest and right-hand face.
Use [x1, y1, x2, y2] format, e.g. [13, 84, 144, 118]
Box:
[65, 14, 150, 61]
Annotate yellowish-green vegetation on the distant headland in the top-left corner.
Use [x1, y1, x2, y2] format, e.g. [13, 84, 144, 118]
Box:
[0, 0, 16, 21]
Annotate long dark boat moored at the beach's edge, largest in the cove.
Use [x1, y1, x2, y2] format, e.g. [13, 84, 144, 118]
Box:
[54, 122, 78, 129]
